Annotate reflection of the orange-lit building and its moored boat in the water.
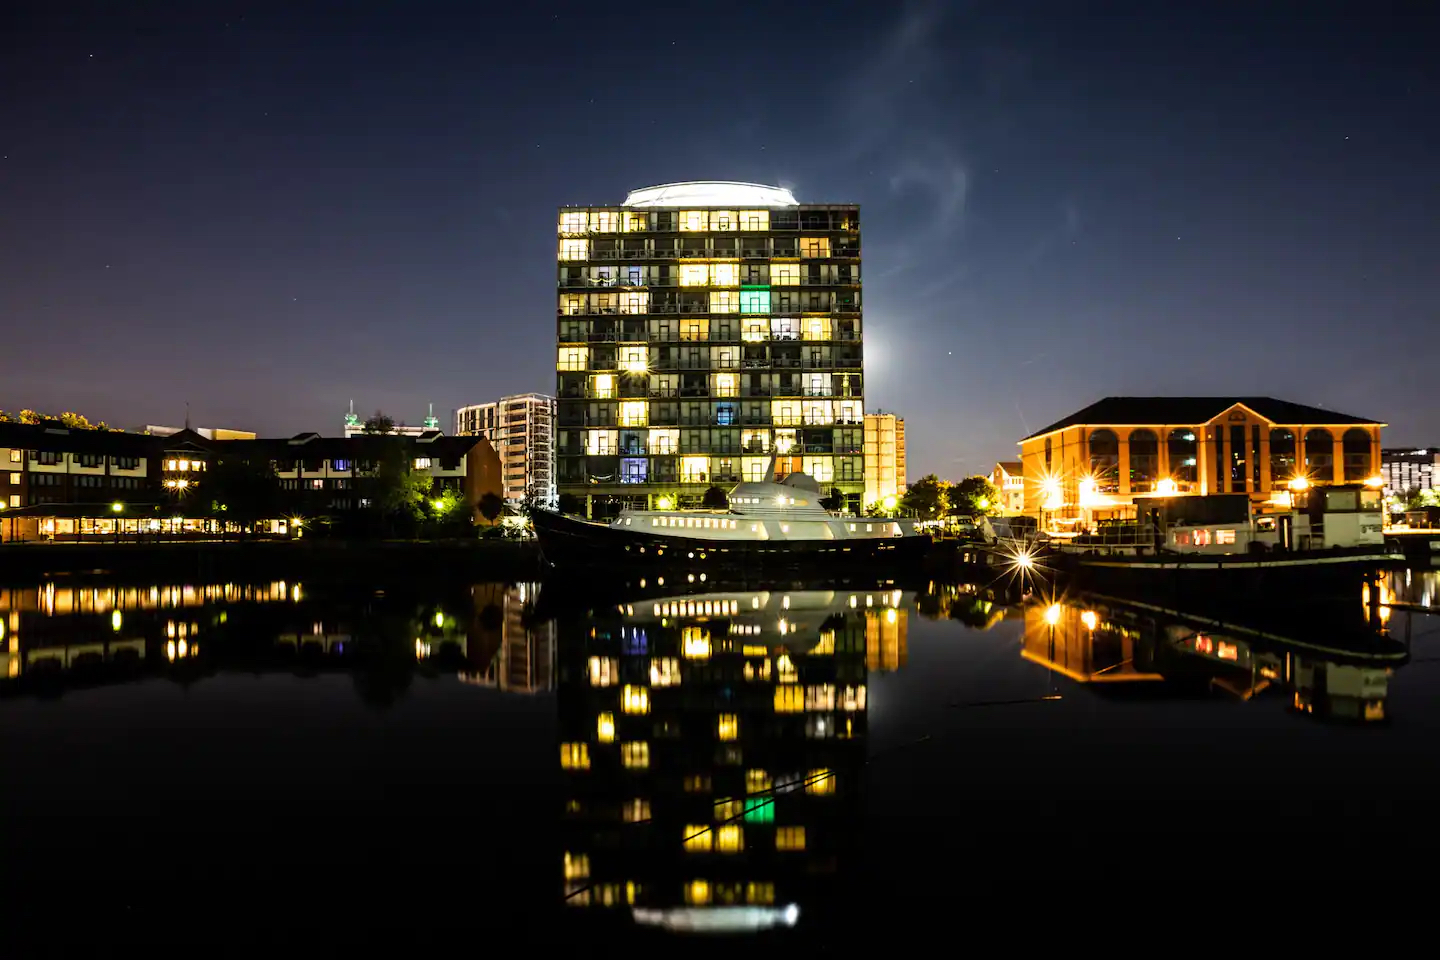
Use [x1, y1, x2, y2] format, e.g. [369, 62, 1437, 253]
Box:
[1021, 592, 1408, 721]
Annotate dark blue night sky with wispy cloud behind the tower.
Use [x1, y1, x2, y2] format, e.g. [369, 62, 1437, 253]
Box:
[0, 0, 1440, 478]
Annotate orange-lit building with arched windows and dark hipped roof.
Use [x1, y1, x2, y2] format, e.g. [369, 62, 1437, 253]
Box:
[1020, 397, 1385, 521]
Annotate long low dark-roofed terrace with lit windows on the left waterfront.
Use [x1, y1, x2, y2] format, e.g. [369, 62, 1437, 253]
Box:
[0, 423, 501, 540]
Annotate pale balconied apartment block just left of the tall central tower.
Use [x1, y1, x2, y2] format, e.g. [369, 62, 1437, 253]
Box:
[455, 393, 556, 504]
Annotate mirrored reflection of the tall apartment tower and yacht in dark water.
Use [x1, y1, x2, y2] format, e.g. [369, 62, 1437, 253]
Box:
[557, 589, 914, 933]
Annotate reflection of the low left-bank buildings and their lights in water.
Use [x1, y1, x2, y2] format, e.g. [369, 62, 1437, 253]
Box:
[0, 580, 554, 702]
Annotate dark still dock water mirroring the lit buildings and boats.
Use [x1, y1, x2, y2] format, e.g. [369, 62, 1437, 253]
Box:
[0, 571, 1440, 953]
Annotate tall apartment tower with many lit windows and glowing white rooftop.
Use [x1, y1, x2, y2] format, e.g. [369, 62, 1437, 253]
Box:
[556, 183, 865, 515]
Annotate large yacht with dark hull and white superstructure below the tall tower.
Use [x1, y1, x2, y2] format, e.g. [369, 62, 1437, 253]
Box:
[531, 458, 932, 580]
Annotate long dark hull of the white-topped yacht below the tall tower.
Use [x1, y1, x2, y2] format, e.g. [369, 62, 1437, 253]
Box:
[531, 511, 930, 580]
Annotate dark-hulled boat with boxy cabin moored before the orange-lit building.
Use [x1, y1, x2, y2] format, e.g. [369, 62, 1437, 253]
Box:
[1035, 484, 1397, 603]
